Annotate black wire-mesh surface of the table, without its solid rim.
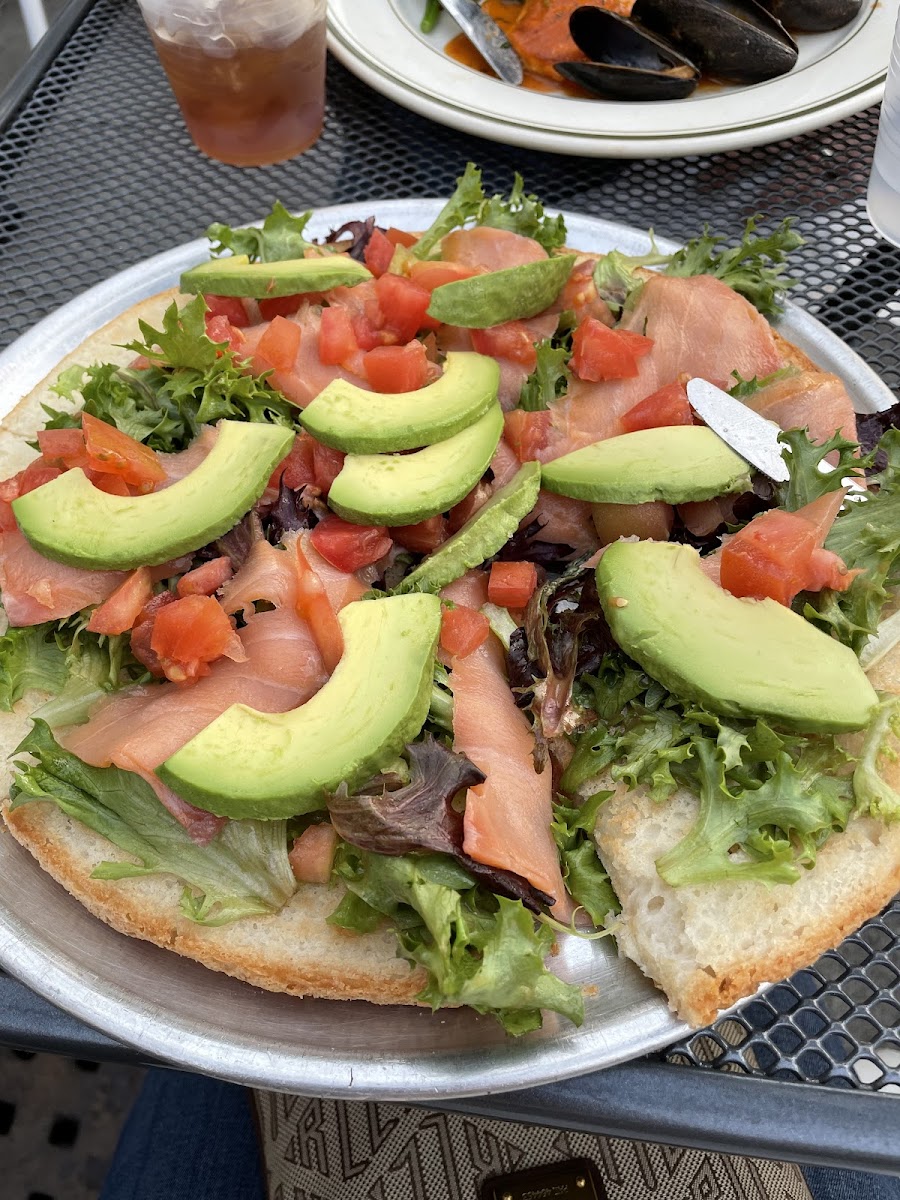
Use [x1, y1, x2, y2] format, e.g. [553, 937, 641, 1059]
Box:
[0, 0, 900, 1116]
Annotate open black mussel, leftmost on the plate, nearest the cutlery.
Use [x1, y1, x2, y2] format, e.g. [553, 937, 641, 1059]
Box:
[556, 6, 700, 100]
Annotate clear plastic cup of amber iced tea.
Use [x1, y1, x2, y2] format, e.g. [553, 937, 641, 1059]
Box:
[139, 0, 325, 167]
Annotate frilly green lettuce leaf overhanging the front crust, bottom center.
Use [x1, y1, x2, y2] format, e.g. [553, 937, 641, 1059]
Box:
[329, 845, 583, 1034]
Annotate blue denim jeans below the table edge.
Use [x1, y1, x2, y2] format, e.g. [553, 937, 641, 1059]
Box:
[100, 1070, 900, 1200]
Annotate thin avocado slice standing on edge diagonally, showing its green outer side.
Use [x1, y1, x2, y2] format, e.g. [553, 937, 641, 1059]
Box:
[395, 462, 541, 594]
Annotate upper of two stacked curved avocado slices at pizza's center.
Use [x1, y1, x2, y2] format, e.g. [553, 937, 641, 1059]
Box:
[300, 352, 500, 454]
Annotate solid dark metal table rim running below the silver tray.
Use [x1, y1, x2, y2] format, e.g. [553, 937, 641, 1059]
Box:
[0, 976, 900, 1174]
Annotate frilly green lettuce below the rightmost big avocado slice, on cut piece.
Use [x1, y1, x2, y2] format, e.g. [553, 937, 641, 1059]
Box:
[560, 655, 853, 886]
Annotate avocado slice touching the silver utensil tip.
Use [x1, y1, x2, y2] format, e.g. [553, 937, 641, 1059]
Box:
[541, 425, 750, 504]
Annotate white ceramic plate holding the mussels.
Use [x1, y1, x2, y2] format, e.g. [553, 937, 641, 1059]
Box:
[329, 0, 900, 158]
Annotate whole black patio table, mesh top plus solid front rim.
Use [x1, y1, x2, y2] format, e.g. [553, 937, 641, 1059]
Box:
[0, 0, 900, 1172]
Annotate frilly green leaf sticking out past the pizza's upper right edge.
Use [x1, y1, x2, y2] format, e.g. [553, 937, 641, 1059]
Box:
[665, 217, 803, 317]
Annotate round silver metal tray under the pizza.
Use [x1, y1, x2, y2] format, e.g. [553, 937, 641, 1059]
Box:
[0, 199, 894, 1102]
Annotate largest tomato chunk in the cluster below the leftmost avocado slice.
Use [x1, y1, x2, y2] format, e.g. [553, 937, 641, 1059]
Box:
[150, 595, 244, 683]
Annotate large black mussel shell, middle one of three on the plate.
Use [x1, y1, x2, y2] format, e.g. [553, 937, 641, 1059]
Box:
[631, 0, 797, 83]
